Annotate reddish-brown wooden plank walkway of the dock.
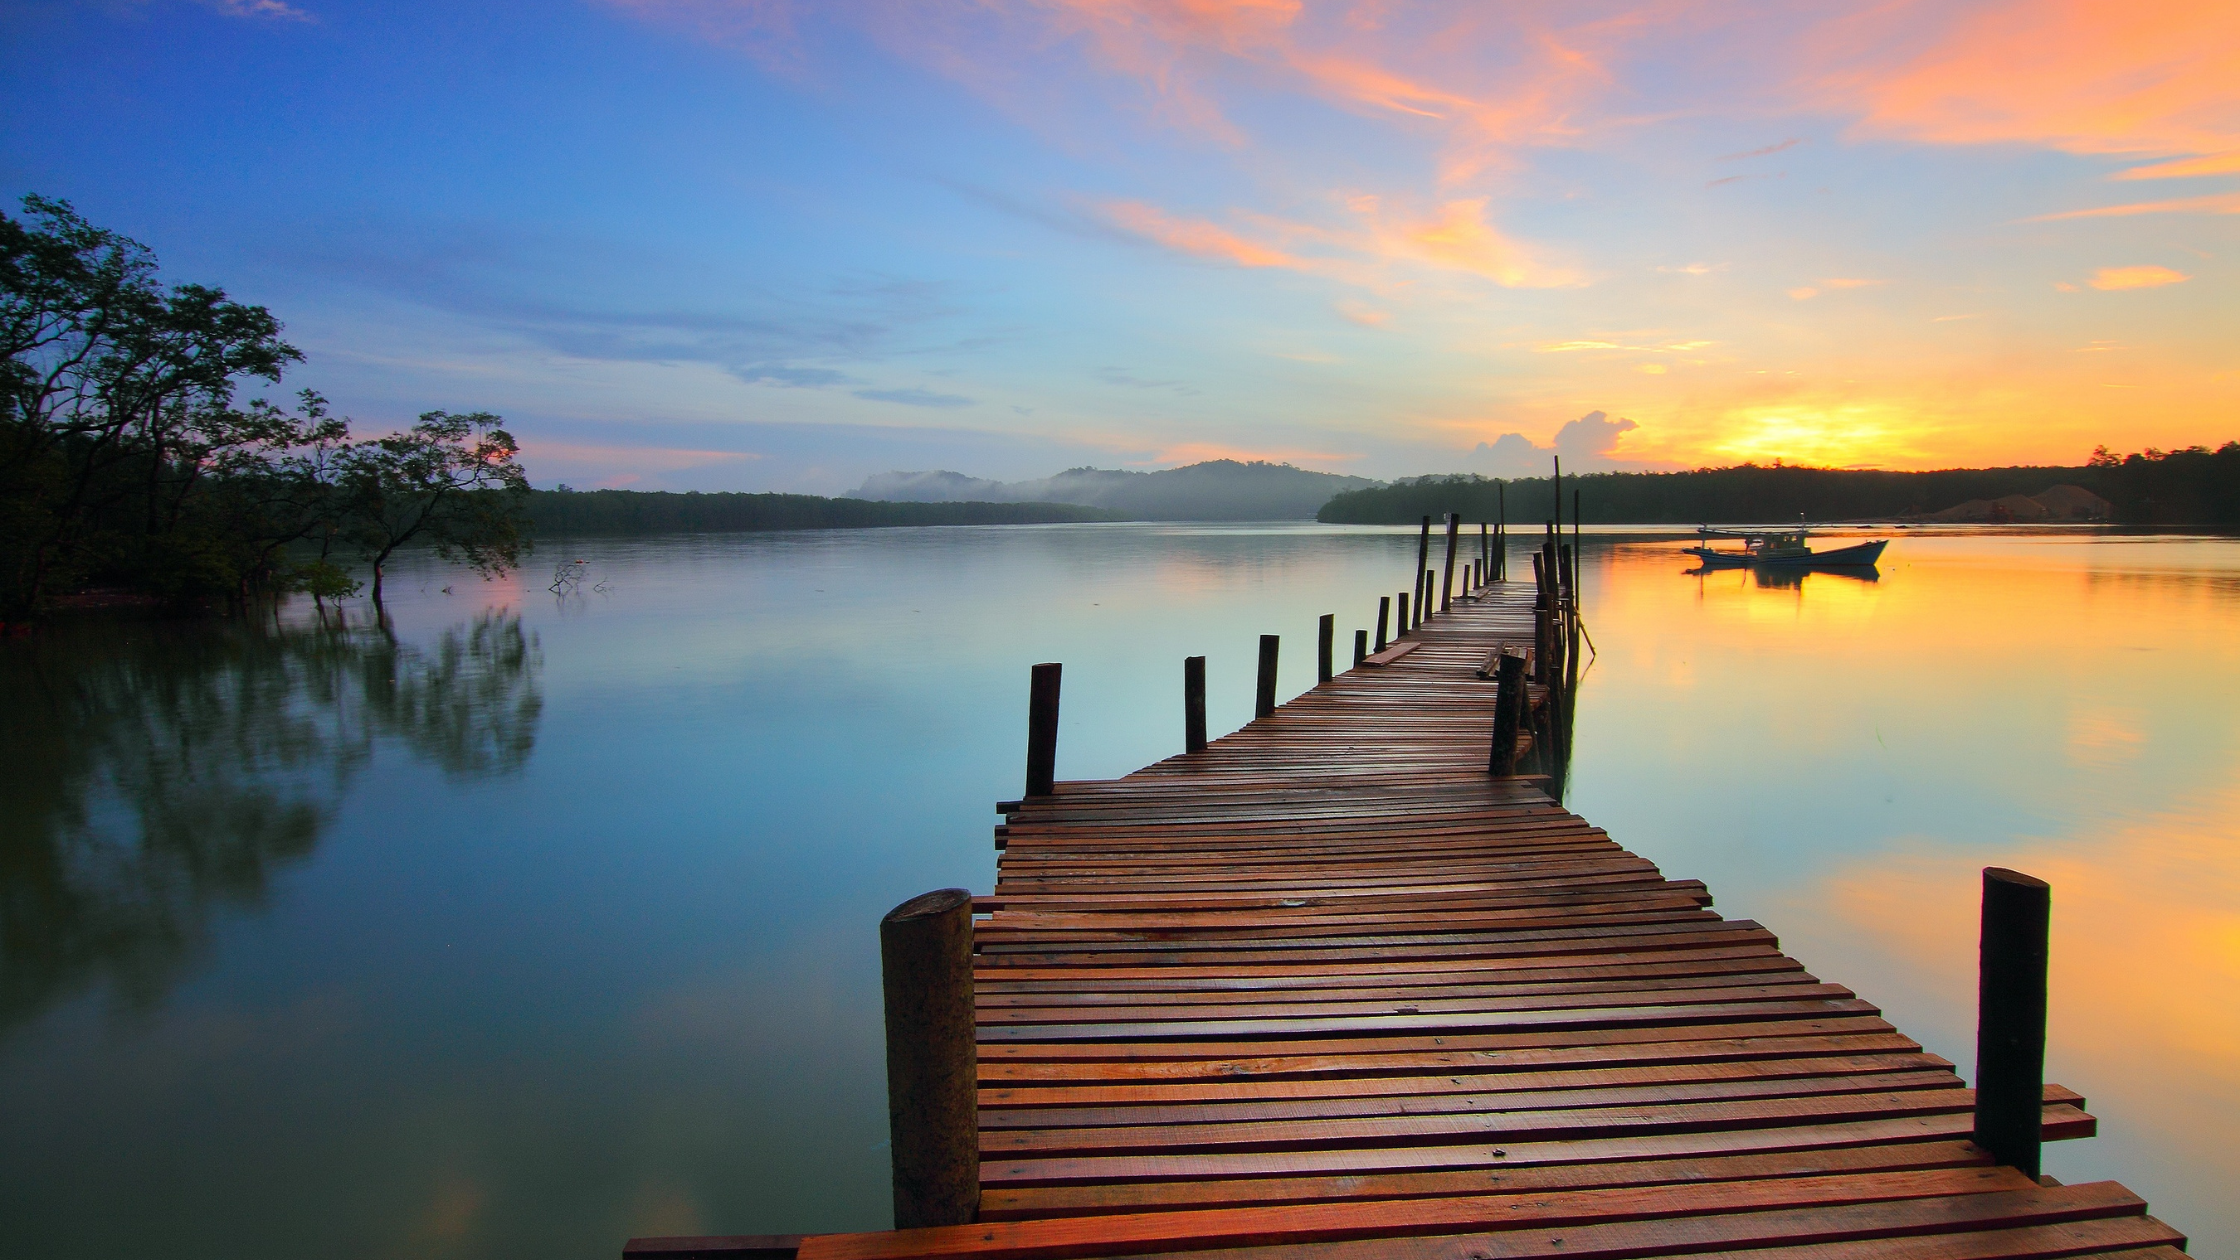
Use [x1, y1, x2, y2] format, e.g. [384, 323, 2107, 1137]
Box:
[647, 587, 2186, 1260]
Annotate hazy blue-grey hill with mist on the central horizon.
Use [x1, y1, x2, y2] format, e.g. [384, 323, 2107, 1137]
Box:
[853, 460, 1380, 520]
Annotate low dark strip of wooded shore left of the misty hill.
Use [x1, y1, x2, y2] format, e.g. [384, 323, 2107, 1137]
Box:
[529, 491, 1122, 538]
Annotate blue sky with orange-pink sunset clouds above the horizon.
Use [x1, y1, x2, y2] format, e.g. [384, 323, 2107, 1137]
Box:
[0, 0, 2240, 493]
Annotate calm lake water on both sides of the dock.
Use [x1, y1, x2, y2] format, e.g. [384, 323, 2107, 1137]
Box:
[0, 525, 2240, 1260]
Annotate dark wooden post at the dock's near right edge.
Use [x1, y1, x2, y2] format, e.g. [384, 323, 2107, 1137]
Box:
[1976, 865, 2052, 1177]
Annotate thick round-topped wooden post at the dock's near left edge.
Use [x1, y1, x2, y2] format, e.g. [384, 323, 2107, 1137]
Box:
[878, 888, 979, 1229]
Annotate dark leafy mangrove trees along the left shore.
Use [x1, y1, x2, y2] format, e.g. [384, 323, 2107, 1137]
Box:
[0, 195, 529, 621]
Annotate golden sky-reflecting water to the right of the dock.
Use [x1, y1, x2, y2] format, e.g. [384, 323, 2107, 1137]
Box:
[1570, 524, 2240, 1258]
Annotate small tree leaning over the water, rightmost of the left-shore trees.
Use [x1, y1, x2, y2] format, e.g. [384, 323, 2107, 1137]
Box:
[340, 410, 529, 603]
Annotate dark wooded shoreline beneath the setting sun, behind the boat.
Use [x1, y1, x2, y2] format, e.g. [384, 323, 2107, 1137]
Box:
[1315, 442, 2240, 525]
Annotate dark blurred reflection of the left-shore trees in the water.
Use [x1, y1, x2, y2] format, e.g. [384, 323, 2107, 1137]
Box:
[0, 612, 544, 1029]
